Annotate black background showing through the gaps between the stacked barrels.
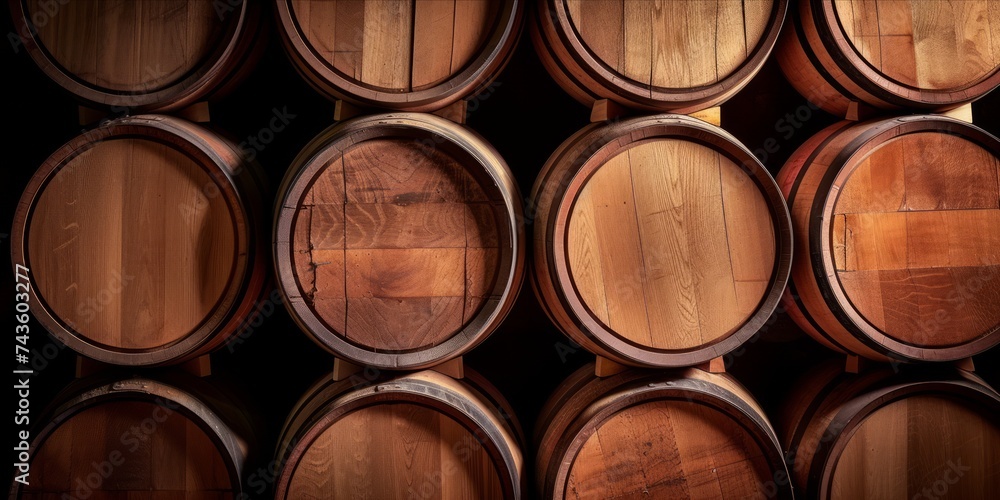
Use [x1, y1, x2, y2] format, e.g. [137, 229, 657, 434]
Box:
[0, 2, 1000, 493]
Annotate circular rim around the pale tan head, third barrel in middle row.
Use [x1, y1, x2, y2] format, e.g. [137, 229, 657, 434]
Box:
[536, 115, 793, 367]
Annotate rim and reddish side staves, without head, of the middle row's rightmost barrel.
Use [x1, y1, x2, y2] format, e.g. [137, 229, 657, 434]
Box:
[779, 115, 1000, 362]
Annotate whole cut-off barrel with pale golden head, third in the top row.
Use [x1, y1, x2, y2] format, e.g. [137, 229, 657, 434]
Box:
[530, 0, 788, 113]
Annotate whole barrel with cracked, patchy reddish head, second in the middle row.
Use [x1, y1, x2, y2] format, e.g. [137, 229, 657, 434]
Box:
[274, 113, 525, 369]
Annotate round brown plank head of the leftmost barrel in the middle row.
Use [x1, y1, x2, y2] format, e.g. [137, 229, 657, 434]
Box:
[28, 138, 236, 349]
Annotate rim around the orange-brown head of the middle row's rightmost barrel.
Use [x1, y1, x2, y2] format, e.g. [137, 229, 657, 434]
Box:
[808, 115, 1000, 361]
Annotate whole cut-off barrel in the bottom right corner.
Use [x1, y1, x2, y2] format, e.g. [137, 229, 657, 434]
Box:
[778, 361, 1000, 500]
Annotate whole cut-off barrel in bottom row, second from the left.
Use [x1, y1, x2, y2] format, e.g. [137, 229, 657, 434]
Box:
[275, 371, 524, 500]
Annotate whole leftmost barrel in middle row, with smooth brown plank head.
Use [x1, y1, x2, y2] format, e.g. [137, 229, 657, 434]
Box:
[12, 115, 267, 365]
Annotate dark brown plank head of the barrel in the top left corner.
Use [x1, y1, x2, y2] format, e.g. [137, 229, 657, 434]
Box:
[26, 0, 227, 92]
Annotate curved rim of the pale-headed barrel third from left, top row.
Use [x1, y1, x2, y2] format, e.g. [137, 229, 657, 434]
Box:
[533, 0, 789, 112]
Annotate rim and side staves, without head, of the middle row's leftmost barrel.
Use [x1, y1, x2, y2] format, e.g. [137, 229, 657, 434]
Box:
[11, 115, 269, 366]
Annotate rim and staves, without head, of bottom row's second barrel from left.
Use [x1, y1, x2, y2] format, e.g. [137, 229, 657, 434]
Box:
[275, 368, 527, 498]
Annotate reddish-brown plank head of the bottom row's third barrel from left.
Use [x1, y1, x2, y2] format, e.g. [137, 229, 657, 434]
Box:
[566, 401, 772, 500]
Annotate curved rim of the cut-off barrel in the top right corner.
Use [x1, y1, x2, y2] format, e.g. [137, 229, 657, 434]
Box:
[816, 0, 1000, 107]
